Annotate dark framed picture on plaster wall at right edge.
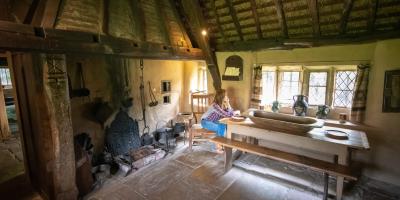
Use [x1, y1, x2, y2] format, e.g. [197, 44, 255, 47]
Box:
[382, 70, 400, 112]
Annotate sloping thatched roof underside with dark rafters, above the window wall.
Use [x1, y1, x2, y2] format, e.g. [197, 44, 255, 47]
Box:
[200, 0, 400, 50]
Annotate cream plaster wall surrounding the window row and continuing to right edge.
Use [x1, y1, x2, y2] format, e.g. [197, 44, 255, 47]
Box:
[217, 39, 400, 185]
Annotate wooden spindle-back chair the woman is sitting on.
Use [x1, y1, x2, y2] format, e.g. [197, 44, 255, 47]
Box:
[189, 93, 216, 149]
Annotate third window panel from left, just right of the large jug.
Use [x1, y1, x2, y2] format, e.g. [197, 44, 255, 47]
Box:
[308, 72, 328, 105]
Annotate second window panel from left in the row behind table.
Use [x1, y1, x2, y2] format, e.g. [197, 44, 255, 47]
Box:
[278, 71, 300, 104]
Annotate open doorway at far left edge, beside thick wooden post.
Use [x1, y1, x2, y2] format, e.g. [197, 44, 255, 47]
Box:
[0, 51, 31, 197]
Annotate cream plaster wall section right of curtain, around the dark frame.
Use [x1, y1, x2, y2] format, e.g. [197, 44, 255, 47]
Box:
[364, 40, 400, 185]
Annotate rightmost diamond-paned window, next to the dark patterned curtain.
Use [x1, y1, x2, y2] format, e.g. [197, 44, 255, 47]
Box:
[333, 71, 357, 108]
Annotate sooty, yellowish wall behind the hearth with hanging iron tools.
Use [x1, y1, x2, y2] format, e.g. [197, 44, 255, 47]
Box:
[67, 55, 192, 153]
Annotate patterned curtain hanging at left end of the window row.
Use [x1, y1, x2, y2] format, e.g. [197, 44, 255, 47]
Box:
[250, 66, 262, 109]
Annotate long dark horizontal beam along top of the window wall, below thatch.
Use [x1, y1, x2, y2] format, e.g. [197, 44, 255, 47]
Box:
[216, 30, 400, 52]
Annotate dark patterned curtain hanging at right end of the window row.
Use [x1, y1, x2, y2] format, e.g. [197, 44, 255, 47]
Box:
[350, 64, 370, 123]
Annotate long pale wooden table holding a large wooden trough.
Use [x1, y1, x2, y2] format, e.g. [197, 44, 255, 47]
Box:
[220, 118, 370, 199]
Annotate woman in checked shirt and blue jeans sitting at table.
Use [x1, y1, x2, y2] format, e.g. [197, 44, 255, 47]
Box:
[201, 89, 234, 137]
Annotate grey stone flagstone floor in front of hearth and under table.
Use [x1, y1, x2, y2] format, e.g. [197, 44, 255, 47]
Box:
[84, 142, 399, 200]
